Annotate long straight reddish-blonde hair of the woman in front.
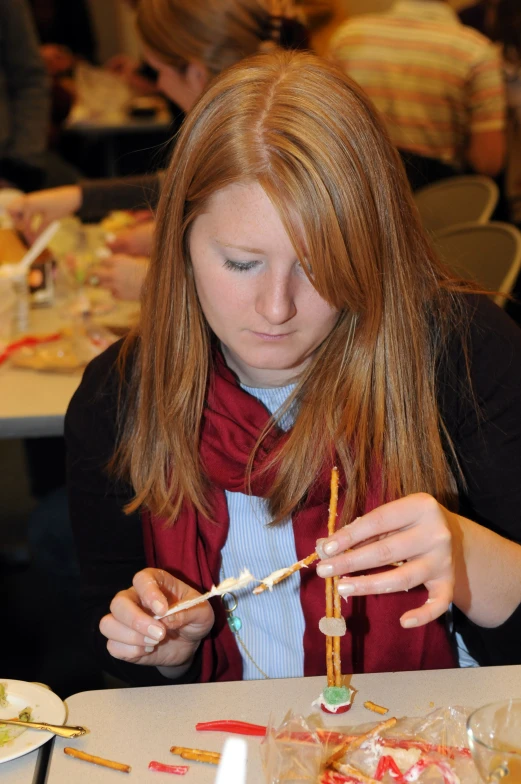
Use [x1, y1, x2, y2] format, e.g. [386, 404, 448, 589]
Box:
[113, 51, 474, 523]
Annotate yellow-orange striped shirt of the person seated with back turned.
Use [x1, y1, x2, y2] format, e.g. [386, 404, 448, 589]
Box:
[328, 0, 505, 168]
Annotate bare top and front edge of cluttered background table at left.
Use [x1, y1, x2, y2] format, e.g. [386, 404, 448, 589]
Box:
[0, 302, 138, 438]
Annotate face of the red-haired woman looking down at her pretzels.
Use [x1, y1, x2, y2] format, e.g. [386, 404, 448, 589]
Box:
[189, 178, 338, 387]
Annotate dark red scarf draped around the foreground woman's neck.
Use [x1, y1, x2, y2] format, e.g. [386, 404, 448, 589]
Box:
[143, 353, 456, 681]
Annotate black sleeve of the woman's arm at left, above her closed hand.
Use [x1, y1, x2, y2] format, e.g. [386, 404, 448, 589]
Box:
[65, 343, 204, 686]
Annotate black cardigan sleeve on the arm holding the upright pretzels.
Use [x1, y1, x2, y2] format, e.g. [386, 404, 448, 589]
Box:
[440, 297, 521, 665]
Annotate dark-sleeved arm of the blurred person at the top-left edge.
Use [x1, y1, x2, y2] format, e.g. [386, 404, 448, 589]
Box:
[0, 0, 50, 160]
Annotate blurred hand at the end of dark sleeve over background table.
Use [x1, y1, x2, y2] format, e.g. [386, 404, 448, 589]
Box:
[8, 185, 83, 242]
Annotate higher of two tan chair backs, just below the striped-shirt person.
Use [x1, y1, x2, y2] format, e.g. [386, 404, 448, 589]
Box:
[414, 174, 499, 233]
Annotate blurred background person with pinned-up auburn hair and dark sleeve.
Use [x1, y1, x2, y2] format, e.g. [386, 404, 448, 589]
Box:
[10, 0, 330, 296]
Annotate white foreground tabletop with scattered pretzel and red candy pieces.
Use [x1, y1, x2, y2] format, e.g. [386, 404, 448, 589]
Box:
[46, 666, 521, 784]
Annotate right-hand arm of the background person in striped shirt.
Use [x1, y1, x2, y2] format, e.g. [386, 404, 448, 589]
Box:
[466, 45, 506, 177]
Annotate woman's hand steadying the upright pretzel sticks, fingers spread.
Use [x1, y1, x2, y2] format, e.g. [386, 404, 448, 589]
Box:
[317, 493, 459, 628]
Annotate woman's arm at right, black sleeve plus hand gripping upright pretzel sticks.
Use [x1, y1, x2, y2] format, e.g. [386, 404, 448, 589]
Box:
[317, 297, 521, 660]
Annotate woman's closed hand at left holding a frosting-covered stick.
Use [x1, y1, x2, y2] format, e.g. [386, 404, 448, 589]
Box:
[100, 569, 214, 667]
